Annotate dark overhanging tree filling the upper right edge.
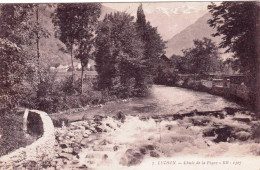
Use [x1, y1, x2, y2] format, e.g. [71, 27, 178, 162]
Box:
[208, 1, 260, 110]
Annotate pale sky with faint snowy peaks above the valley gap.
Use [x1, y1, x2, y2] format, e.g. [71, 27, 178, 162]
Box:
[103, 2, 210, 40]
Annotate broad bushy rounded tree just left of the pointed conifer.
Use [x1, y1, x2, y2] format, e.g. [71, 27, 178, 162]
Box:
[95, 12, 145, 98]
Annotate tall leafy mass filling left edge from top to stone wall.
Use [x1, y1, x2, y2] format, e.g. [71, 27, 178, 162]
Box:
[0, 4, 33, 111]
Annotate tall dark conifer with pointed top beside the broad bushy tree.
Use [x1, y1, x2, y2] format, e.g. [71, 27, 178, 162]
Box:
[136, 4, 166, 84]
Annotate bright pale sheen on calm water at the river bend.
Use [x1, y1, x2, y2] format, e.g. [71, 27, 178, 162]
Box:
[149, 86, 240, 114]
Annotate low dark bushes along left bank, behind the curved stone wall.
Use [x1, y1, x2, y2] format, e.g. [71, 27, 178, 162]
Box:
[21, 69, 120, 113]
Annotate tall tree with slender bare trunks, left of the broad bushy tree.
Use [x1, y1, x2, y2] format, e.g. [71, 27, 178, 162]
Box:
[53, 3, 101, 87]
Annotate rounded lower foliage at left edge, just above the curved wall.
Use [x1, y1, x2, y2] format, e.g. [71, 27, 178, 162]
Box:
[0, 38, 25, 112]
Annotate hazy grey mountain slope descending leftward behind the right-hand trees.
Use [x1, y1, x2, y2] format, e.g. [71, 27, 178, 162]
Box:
[166, 13, 221, 57]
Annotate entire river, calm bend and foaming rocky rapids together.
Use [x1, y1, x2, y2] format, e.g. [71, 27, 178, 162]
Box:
[51, 85, 260, 170]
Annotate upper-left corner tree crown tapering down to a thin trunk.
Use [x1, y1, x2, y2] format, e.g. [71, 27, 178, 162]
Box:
[0, 4, 49, 81]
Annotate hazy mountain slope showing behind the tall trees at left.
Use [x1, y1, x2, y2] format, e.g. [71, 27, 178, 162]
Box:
[39, 6, 116, 66]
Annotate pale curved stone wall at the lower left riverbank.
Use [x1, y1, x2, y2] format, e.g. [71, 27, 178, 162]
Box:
[0, 110, 55, 169]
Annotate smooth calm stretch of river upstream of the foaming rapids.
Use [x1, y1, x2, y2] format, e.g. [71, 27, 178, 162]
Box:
[86, 85, 240, 115]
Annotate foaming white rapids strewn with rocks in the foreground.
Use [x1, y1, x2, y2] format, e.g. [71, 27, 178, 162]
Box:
[43, 108, 260, 170]
